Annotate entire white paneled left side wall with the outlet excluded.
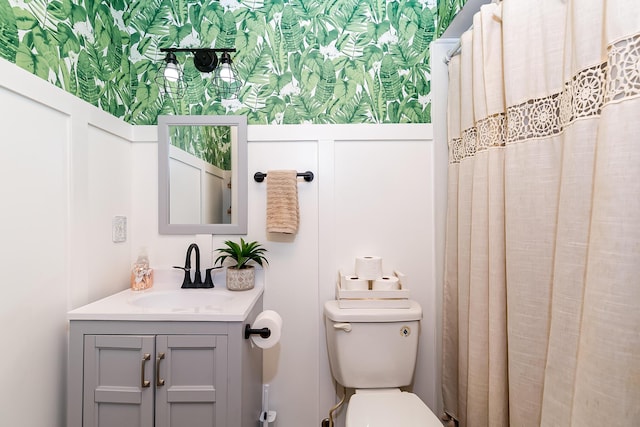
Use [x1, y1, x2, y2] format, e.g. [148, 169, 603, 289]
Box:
[0, 59, 132, 427]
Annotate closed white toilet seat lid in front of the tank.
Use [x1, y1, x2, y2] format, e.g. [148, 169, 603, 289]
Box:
[346, 389, 442, 427]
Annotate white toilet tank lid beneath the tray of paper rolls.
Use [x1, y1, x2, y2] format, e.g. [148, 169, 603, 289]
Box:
[324, 300, 422, 323]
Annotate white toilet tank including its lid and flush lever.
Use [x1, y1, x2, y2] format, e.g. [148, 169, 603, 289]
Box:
[324, 301, 422, 389]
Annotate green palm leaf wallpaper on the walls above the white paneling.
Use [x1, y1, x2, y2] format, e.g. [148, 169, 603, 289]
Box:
[0, 0, 464, 124]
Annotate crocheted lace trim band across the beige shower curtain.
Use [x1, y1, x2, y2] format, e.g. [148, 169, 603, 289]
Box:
[449, 34, 640, 163]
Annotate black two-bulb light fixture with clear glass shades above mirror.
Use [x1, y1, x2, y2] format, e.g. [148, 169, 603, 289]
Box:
[156, 47, 240, 99]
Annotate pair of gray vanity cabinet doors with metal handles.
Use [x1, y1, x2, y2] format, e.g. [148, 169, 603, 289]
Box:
[83, 335, 227, 427]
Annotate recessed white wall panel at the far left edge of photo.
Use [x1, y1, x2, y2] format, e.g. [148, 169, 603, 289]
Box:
[0, 73, 69, 426]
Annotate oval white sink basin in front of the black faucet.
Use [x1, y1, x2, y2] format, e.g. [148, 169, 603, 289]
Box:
[131, 289, 233, 311]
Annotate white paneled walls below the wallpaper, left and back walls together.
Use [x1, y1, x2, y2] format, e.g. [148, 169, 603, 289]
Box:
[0, 56, 444, 427]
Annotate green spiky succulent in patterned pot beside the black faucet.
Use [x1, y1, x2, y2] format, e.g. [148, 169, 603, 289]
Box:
[215, 238, 269, 291]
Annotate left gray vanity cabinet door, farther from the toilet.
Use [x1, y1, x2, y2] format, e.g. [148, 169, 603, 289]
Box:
[82, 335, 155, 427]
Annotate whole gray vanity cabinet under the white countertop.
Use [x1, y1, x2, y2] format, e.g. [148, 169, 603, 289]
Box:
[67, 297, 262, 427]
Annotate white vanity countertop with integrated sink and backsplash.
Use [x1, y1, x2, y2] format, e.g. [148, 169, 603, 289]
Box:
[67, 271, 264, 322]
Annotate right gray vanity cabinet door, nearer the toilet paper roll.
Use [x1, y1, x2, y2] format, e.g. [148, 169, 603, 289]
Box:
[156, 335, 227, 427]
